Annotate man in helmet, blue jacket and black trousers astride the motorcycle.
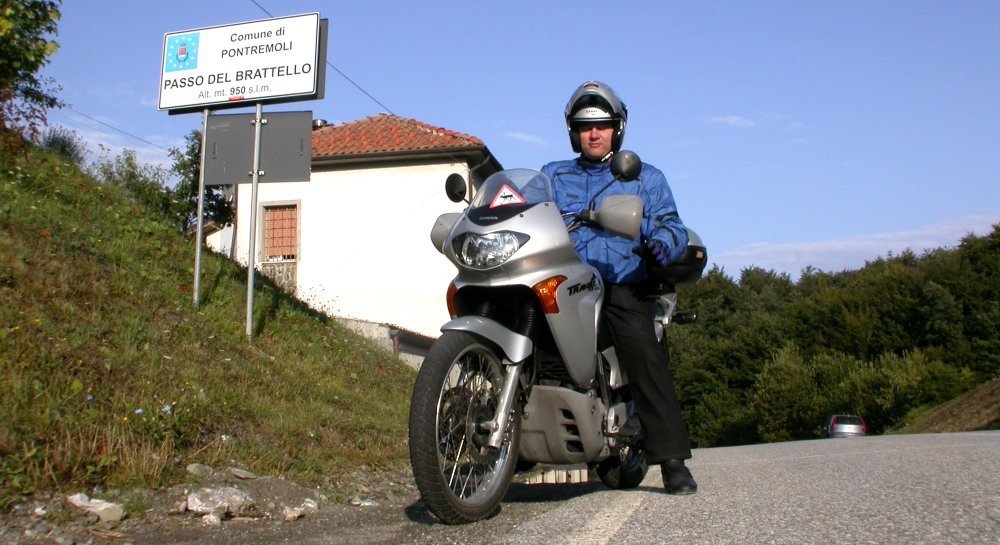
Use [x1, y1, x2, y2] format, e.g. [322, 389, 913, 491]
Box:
[542, 81, 698, 494]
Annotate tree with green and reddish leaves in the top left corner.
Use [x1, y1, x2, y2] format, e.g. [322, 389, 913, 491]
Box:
[0, 0, 62, 149]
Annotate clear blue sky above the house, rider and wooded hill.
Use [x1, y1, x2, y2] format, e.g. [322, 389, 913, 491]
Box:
[43, 0, 1000, 278]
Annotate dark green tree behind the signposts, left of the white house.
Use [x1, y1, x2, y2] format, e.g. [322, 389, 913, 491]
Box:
[170, 131, 233, 235]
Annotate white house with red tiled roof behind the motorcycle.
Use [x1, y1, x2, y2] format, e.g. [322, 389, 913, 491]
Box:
[208, 114, 502, 354]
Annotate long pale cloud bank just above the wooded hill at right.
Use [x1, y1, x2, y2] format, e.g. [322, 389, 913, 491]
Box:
[709, 216, 1000, 279]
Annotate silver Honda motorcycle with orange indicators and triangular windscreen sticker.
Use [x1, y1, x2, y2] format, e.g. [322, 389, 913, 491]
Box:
[409, 151, 707, 524]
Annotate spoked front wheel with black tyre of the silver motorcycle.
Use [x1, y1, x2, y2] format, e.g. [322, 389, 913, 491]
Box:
[410, 331, 521, 524]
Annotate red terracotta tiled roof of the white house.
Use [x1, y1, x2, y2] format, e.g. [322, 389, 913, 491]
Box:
[312, 114, 483, 157]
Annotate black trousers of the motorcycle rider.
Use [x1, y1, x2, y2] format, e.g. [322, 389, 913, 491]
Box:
[603, 284, 691, 465]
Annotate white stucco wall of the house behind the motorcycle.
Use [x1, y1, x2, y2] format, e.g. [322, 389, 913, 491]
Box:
[227, 160, 467, 337]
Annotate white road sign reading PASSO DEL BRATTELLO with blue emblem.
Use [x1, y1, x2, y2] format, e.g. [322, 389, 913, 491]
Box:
[159, 13, 321, 110]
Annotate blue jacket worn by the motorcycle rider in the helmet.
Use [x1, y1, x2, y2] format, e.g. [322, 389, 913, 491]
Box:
[542, 158, 688, 284]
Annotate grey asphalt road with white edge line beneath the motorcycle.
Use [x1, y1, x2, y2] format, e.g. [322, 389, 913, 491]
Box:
[131, 431, 1000, 545]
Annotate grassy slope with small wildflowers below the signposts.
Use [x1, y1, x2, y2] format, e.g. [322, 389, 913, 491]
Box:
[0, 146, 413, 506]
